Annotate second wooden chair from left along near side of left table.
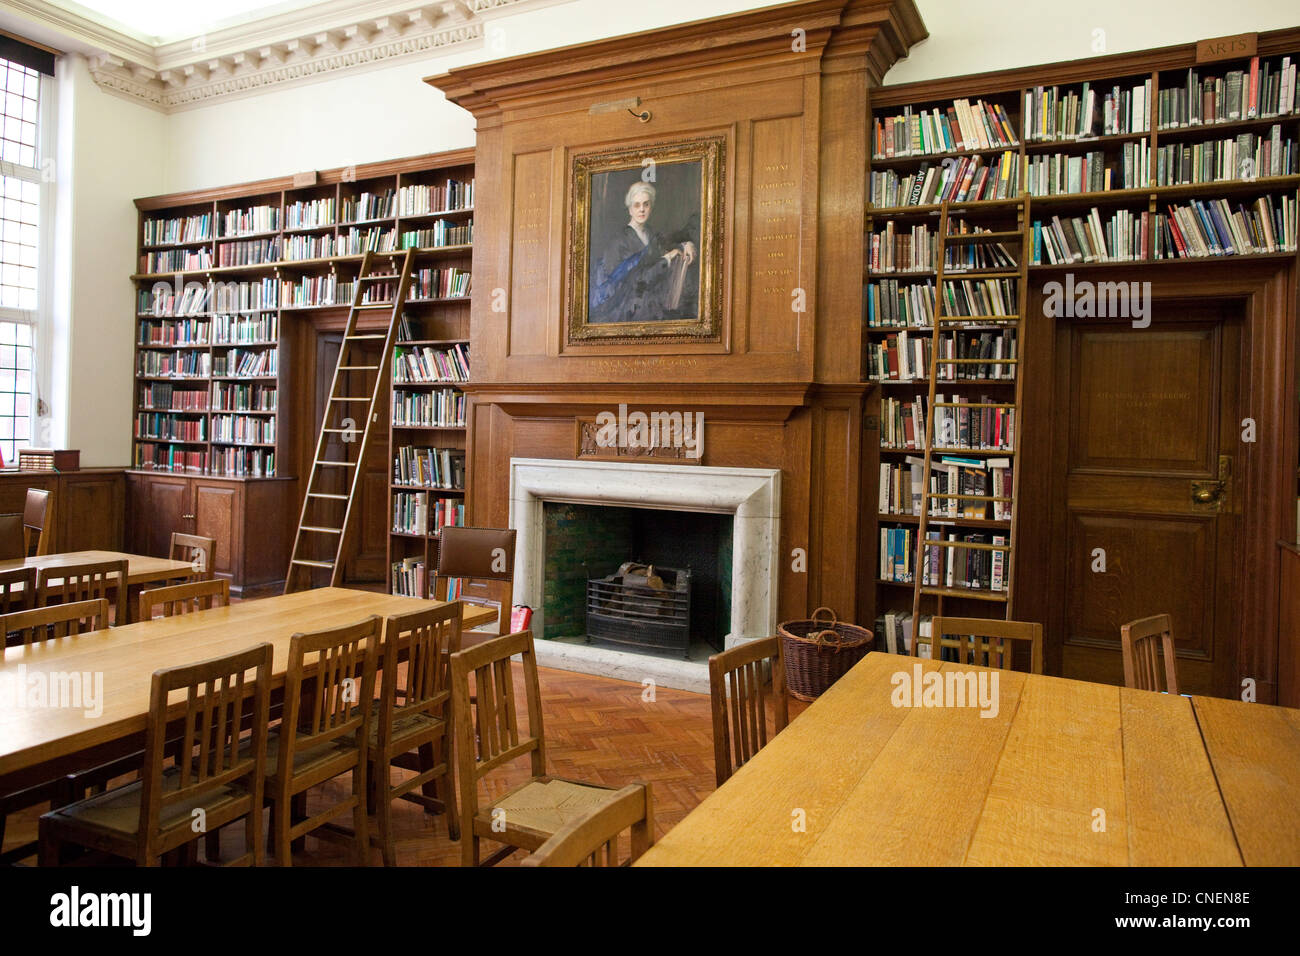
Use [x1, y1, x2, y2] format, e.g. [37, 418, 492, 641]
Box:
[267, 614, 382, 866]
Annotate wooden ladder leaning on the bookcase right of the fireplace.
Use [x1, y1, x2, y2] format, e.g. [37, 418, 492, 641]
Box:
[911, 195, 1031, 659]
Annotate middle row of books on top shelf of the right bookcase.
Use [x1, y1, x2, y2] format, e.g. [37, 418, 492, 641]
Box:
[1023, 79, 1151, 143]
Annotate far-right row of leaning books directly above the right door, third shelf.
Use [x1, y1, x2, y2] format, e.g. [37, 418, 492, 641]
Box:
[1153, 193, 1296, 259]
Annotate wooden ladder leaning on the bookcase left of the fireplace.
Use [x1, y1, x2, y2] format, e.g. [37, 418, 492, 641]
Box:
[285, 250, 415, 594]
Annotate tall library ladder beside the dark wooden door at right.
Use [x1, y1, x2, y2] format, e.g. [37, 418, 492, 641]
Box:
[911, 196, 1031, 658]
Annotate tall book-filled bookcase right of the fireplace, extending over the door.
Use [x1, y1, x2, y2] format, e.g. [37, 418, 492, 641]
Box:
[862, 41, 1300, 660]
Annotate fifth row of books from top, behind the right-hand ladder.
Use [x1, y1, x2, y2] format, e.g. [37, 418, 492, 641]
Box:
[866, 329, 1017, 381]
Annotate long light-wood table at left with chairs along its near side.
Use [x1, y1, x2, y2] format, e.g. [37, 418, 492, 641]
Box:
[0, 590, 497, 793]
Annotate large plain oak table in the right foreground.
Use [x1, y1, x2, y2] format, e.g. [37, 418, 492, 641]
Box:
[637, 653, 1300, 866]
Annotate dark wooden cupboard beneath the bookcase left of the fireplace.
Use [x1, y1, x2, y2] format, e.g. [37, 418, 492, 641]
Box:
[126, 472, 298, 597]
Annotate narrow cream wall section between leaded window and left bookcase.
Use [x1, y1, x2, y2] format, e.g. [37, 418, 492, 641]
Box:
[52, 55, 165, 467]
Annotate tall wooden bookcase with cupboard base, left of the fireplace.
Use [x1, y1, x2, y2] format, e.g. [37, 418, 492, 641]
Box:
[127, 150, 473, 593]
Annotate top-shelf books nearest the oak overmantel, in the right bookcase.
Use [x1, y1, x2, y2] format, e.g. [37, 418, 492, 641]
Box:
[871, 99, 1019, 159]
